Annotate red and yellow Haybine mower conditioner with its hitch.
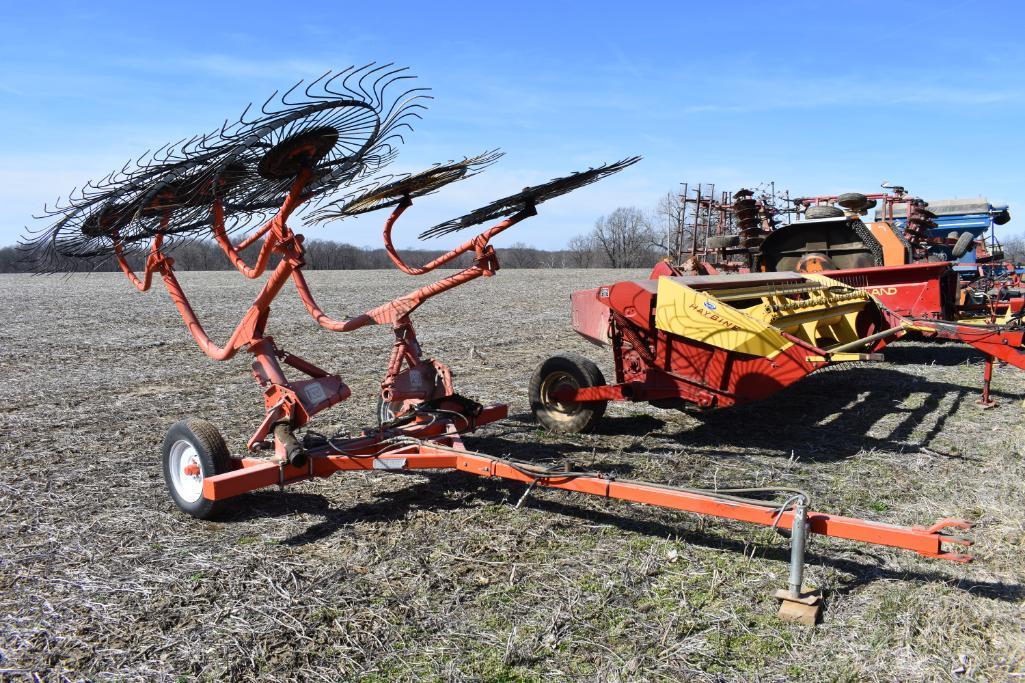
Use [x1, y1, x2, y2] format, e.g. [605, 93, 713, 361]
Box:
[545, 264, 1025, 433]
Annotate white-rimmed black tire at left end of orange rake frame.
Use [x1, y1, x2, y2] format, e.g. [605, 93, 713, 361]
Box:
[162, 418, 233, 519]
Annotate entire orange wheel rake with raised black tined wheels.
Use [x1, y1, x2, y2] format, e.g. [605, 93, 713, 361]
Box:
[22, 65, 984, 623]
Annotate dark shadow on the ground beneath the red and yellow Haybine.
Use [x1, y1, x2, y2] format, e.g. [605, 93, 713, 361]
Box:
[489, 367, 1019, 463]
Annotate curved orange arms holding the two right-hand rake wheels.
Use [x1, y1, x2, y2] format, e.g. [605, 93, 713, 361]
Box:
[292, 202, 537, 332]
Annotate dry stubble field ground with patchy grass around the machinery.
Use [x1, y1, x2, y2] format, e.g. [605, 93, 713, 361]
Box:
[0, 270, 1025, 681]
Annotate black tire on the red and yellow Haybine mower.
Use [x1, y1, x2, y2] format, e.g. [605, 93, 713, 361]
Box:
[528, 353, 608, 434]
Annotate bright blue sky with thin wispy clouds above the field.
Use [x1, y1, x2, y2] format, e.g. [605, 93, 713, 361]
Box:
[0, 0, 1025, 248]
